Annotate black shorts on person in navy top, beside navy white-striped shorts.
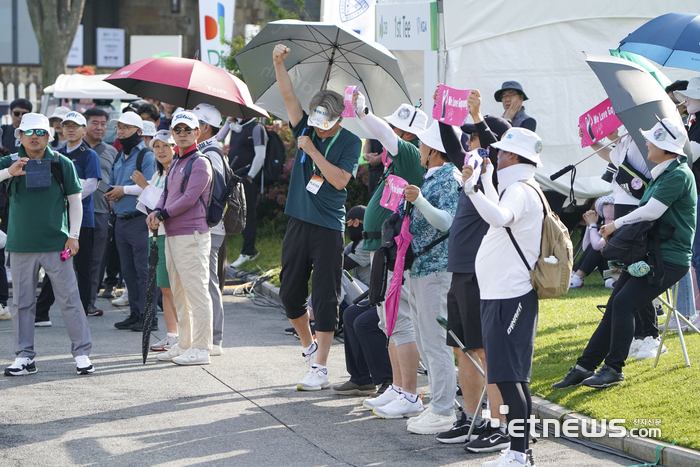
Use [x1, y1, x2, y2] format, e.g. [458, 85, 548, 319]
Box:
[447, 272, 484, 350]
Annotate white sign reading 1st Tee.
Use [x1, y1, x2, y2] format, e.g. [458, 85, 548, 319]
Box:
[375, 2, 437, 50]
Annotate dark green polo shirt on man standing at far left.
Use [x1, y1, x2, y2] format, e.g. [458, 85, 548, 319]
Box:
[0, 146, 83, 253]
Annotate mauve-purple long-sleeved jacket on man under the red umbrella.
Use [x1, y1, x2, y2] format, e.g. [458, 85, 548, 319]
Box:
[156, 145, 212, 237]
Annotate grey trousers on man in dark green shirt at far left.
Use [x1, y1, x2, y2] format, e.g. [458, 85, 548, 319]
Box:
[10, 251, 92, 359]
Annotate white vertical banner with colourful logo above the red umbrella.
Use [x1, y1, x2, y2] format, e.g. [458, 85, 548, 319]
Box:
[199, 0, 236, 68]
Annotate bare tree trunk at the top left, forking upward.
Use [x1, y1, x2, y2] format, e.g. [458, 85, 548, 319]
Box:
[27, 0, 85, 87]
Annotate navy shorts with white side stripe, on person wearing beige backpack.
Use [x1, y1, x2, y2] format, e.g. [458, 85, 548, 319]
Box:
[481, 290, 539, 383]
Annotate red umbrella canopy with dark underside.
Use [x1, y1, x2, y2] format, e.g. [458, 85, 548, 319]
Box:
[105, 57, 269, 118]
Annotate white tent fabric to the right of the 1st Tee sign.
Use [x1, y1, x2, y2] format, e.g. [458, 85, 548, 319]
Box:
[443, 0, 700, 198]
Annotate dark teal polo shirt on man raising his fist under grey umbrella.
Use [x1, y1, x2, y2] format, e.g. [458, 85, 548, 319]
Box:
[284, 112, 362, 232]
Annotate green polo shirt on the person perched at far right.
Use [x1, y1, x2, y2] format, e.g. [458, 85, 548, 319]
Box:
[639, 156, 698, 266]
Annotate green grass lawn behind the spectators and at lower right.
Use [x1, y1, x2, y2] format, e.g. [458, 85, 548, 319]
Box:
[228, 227, 700, 449]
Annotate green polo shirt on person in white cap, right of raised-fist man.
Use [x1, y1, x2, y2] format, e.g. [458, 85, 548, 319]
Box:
[362, 138, 425, 251]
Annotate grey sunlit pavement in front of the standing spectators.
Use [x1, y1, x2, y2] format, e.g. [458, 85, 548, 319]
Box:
[0, 296, 635, 467]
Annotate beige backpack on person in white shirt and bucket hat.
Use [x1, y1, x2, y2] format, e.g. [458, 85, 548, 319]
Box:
[506, 182, 574, 298]
